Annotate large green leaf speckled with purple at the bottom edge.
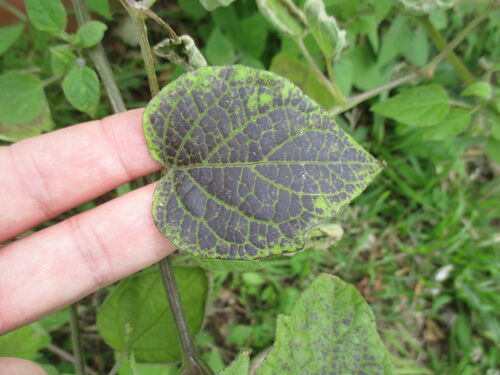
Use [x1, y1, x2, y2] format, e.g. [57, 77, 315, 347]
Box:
[257, 274, 393, 375]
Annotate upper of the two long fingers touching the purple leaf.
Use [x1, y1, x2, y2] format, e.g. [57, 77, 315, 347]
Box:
[0, 110, 160, 242]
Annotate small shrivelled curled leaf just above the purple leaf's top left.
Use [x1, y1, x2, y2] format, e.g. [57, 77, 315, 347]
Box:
[153, 35, 207, 70]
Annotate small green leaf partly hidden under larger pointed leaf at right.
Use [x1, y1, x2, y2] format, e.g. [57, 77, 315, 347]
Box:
[421, 109, 472, 141]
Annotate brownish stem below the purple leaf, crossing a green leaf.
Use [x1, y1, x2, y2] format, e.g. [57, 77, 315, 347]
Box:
[159, 257, 212, 374]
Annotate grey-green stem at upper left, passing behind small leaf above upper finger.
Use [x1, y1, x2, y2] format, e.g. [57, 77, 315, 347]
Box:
[72, 0, 127, 113]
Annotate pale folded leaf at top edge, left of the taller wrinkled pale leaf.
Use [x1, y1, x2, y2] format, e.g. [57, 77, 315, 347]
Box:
[257, 0, 307, 38]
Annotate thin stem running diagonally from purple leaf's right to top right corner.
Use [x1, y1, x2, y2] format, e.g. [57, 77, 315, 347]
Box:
[330, 2, 500, 115]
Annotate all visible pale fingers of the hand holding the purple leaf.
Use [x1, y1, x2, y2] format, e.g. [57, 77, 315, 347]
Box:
[0, 110, 175, 375]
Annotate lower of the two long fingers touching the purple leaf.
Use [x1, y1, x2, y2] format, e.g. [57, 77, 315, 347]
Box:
[0, 184, 174, 334]
